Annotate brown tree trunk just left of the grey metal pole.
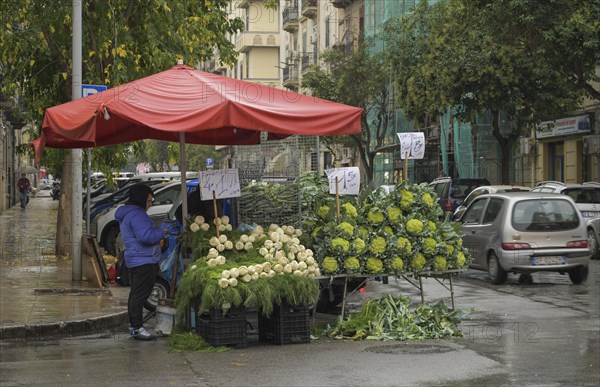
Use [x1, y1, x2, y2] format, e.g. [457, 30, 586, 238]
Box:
[55, 151, 73, 257]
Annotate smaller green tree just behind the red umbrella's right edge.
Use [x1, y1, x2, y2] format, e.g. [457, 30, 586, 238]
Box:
[302, 39, 393, 184]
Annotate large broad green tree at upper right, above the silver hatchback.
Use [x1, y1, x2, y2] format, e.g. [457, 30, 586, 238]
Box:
[384, 0, 600, 183]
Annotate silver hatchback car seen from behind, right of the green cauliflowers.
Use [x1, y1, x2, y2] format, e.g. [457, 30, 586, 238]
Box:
[461, 192, 591, 284]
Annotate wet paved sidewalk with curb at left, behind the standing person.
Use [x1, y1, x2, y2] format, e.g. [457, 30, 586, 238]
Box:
[0, 191, 129, 340]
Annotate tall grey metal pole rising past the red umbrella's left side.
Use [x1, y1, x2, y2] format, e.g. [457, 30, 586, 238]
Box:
[71, 0, 82, 281]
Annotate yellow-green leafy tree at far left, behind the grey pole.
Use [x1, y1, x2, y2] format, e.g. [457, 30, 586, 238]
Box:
[0, 0, 243, 255]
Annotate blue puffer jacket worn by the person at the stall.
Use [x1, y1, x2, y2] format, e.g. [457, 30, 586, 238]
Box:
[115, 204, 165, 268]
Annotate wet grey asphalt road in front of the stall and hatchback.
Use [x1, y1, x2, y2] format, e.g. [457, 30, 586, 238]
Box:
[0, 261, 600, 387]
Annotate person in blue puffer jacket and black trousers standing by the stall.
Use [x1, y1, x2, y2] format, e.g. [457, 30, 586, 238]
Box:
[115, 184, 165, 340]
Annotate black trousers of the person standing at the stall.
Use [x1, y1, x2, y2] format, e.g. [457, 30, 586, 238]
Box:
[127, 263, 158, 329]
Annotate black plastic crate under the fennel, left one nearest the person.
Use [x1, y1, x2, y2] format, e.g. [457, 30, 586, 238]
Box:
[196, 306, 248, 347]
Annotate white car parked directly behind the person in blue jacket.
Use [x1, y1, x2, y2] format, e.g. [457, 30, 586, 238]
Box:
[96, 181, 189, 256]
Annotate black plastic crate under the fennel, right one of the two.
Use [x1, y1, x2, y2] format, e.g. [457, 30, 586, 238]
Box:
[258, 304, 310, 345]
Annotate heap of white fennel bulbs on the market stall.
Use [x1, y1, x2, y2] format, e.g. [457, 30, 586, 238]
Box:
[189, 216, 321, 289]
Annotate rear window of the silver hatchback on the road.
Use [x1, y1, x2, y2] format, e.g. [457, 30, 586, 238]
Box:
[512, 199, 579, 232]
